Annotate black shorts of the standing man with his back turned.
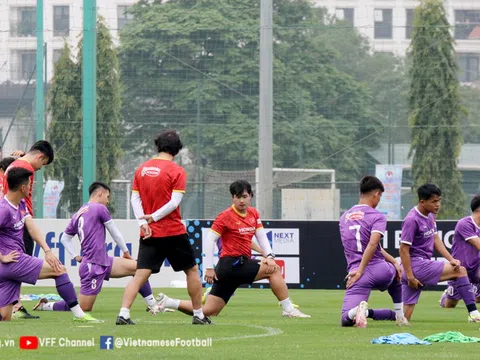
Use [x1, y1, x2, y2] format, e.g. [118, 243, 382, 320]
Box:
[137, 234, 197, 274]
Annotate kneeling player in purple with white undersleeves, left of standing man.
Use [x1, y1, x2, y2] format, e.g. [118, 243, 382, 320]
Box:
[34, 182, 157, 315]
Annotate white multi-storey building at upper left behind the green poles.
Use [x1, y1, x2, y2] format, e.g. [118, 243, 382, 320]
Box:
[0, 0, 136, 152]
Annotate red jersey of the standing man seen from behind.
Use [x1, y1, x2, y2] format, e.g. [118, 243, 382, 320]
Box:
[132, 158, 187, 237]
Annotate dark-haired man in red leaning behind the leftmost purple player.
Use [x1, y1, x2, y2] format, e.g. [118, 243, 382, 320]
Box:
[3, 140, 54, 319]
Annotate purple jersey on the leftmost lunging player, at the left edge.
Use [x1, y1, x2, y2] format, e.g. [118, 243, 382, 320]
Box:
[0, 198, 30, 255]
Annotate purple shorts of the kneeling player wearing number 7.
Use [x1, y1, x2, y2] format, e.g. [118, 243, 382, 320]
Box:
[342, 261, 397, 314]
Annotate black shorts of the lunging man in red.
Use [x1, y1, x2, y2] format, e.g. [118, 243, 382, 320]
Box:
[210, 256, 260, 303]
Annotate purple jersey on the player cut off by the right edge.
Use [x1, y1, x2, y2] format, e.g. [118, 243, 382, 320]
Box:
[452, 216, 480, 272]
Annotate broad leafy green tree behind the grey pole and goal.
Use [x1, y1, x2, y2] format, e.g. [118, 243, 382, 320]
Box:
[120, 0, 380, 179]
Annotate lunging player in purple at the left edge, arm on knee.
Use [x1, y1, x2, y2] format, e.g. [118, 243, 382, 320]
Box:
[0, 168, 99, 322]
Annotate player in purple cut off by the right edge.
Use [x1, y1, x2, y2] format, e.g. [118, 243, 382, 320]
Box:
[440, 195, 480, 308]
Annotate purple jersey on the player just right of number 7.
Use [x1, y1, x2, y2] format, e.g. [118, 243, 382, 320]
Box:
[400, 206, 437, 260]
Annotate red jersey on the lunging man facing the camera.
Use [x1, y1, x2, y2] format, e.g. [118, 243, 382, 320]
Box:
[211, 205, 263, 258]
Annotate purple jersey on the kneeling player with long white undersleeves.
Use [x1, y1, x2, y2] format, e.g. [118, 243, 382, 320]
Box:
[65, 203, 112, 266]
